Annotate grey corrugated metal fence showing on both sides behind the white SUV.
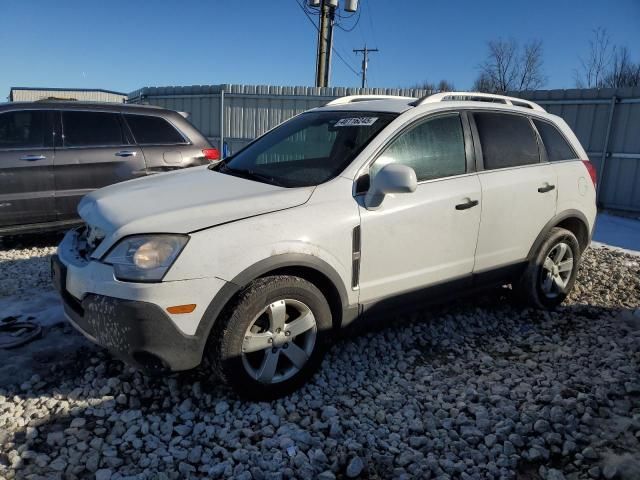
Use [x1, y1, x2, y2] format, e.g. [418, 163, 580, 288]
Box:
[129, 85, 640, 211]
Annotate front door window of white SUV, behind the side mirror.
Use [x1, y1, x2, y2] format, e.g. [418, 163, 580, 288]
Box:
[370, 113, 467, 182]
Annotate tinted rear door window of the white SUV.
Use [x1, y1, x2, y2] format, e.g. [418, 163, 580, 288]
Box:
[473, 112, 540, 170]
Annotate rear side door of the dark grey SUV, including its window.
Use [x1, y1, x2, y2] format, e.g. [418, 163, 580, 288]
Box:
[54, 110, 147, 220]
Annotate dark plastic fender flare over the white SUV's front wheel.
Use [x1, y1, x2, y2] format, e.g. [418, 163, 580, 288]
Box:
[195, 253, 349, 353]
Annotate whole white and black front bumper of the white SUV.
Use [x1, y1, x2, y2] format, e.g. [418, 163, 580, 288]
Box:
[51, 230, 228, 373]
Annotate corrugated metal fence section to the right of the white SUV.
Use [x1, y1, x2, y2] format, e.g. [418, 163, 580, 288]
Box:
[518, 87, 640, 212]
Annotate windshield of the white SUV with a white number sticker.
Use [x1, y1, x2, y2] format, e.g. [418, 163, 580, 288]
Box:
[217, 111, 397, 187]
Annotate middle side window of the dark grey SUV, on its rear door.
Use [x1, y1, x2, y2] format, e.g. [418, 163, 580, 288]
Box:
[62, 111, 127, 147]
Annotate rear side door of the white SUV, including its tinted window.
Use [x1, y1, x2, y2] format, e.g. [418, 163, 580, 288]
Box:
[470, 111, 557, 274]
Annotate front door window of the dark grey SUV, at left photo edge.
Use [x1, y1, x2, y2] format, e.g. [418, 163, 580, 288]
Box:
[0, 110, 45, 148]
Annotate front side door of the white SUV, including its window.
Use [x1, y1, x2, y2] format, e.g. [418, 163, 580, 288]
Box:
[358, 112, 481, 305]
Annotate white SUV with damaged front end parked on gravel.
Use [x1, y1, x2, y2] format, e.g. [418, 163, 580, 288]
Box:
[52, 92, 596, 398]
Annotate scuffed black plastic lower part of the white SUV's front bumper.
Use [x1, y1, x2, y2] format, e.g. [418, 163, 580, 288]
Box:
[51, 255, 205, 373]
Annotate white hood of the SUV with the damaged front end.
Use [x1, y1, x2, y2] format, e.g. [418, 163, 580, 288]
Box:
[78, 167, 314, 238]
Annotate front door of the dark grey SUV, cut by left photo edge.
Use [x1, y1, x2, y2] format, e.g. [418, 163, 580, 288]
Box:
[0, 109, 56, 228]
